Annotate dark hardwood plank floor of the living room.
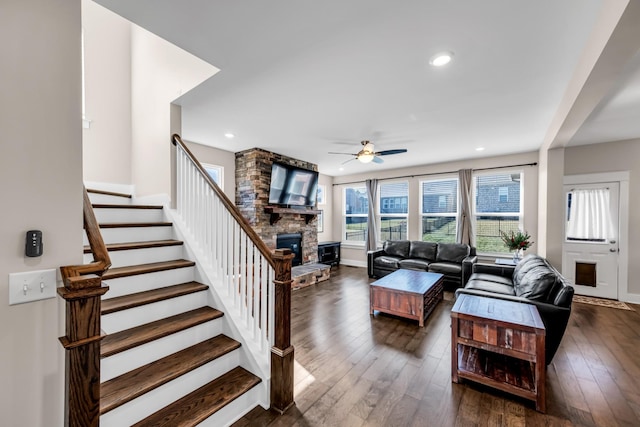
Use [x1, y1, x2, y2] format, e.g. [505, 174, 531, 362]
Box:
[234, 266, 640, 427]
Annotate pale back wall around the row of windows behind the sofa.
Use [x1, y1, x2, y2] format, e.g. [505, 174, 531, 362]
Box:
[331, 152, 538, 266]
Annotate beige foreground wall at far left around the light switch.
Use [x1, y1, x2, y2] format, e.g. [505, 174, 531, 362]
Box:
[0, 0, 82, 427]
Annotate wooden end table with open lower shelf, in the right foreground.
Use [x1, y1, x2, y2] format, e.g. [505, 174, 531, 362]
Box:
[451, 294, 546, 413]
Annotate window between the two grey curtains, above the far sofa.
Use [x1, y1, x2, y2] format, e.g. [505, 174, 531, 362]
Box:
[420, 178, 458, 243]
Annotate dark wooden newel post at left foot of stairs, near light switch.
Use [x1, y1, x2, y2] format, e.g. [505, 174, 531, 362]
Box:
[58, 274, 109, 427]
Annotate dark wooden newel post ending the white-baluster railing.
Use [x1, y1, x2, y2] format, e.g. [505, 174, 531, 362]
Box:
[271, 249, 293, 413]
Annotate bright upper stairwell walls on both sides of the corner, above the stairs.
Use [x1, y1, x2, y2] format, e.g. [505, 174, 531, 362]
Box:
[82, 7, 218, 196]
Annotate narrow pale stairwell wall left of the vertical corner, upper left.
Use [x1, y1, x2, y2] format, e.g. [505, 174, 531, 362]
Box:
[82, 0, 131, 184]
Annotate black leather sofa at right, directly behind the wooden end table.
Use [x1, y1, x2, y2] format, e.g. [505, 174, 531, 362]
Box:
[456, 254, 573, 365]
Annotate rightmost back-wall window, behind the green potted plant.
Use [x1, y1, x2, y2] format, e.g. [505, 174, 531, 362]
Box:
[474, 172, 522, 253]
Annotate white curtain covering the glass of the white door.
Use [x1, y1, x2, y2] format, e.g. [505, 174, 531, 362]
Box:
[567, 188, 611, 240]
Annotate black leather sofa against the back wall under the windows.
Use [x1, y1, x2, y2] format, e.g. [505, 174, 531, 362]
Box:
[367, 240, 477, 287]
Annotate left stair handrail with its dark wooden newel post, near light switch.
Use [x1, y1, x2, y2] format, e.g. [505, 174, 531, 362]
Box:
[58, 189, 111, 427]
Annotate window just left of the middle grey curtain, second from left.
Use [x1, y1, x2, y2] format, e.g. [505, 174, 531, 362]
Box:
[378, 182, 409, 241]
